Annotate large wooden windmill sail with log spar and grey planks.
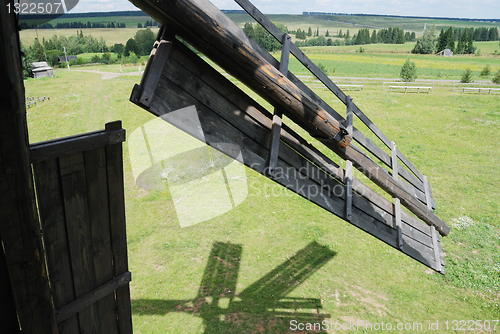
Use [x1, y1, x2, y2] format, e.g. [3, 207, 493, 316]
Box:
[130, 0, 450, 274]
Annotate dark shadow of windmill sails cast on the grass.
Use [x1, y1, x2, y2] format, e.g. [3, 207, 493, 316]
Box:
[132, 241, 336, 333]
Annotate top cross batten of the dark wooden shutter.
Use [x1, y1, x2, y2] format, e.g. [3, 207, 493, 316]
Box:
[30, 129, 125, 163]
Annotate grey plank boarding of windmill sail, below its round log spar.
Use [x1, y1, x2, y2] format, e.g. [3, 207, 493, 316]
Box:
[131, 40, 444, 273]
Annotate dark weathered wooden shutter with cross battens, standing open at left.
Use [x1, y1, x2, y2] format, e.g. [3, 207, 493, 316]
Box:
[31, 122, 132, 334]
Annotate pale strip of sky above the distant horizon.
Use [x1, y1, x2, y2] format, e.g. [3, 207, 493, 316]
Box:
[71, 0, 500, 19]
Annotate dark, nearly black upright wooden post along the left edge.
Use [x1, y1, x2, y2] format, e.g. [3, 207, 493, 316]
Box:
[0, 0, 57, 333]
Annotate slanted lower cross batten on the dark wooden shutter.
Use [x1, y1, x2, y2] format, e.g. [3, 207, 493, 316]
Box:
[56, 271, 132, 324]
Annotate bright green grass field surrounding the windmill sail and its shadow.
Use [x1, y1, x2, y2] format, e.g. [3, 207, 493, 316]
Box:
[25, 29, 500, 334]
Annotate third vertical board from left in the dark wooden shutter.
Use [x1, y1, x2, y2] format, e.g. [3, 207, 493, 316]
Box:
[84, 148, 121, 334]
